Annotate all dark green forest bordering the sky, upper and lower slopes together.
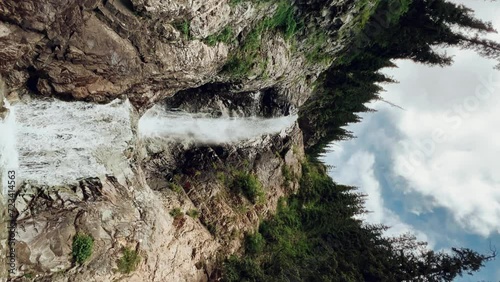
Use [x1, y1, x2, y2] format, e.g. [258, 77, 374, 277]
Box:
[223, 0, 500, 282]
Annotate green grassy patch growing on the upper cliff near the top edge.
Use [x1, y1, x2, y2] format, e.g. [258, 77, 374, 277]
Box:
[223, 0, 299, 78]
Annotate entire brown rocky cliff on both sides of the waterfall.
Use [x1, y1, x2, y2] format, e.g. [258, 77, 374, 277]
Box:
[0, 0, 353, 281]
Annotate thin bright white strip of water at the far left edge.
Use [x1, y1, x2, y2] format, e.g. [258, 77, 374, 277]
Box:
[0, 100, 19, 195]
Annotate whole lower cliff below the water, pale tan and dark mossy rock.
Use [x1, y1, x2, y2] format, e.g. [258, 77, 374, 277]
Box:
[7, 124, 303, 281]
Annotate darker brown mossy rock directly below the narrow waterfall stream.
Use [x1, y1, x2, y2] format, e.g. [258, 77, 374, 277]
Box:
[143, 123, 304, 254]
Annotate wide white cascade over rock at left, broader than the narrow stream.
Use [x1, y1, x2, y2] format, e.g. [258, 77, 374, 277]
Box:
[13, 100, 133, 185]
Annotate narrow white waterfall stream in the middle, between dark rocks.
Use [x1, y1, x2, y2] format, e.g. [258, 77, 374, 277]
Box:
[139, 103, 297, 145]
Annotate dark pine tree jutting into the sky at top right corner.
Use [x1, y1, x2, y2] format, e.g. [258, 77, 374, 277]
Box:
[371, 0, 500, 66]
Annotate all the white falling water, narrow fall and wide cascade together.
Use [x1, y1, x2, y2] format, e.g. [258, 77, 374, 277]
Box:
[0, 92, 297, 188]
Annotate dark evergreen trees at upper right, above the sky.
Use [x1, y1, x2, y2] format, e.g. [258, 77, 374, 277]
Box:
[299, 0, 500, 154]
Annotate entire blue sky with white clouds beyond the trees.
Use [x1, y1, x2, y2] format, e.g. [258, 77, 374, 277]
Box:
[324, 1, 500, 282]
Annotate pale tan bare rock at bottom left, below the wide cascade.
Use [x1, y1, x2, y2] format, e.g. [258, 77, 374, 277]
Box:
[11, 172, 219, 281]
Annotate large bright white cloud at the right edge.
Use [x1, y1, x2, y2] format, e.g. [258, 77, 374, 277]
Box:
[376, 18, 500, 236]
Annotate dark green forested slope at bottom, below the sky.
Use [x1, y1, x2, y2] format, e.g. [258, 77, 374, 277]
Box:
[223, 161, 492, 282]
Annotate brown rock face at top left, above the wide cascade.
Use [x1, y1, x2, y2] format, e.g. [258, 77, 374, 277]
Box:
[0, 1, 229, 107]
